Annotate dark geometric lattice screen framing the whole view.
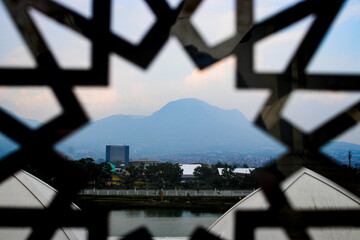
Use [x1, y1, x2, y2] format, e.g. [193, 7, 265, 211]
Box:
[0, 0, 360, 239]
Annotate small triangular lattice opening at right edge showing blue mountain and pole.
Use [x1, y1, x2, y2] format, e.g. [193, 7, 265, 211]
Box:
[320, 124, 360, 168]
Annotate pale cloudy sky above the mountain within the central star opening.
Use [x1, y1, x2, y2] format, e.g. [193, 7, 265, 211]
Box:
[76, 39, 268, 122]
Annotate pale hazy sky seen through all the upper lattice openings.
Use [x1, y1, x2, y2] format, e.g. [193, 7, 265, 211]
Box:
[0, 0, 360, 144]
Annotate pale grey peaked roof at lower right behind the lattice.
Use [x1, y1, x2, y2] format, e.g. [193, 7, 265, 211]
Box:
[209, 168, 360, 240]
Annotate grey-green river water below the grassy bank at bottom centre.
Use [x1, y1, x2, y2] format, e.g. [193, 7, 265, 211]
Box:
[109, 209, 223, 237]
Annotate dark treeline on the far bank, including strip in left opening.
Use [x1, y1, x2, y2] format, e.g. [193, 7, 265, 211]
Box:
[26, 158, 258, 189]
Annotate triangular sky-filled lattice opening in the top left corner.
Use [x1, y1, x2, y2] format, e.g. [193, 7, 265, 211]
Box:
[0, 1, 36, 67]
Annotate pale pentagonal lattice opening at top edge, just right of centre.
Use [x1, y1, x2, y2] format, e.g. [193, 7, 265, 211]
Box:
[191, 0, 236, 46]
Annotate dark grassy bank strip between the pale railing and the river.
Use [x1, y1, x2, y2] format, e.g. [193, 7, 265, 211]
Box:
[75, 195, 240, 211]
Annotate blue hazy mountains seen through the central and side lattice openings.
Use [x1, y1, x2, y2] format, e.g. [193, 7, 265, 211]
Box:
[0, 99, 360, 166]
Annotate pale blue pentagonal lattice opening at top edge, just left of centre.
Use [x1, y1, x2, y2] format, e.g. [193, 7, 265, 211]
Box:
[111, 0, 156, 44]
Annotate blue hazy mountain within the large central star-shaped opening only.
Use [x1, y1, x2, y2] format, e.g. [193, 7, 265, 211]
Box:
[57, 99, 285, 162]
